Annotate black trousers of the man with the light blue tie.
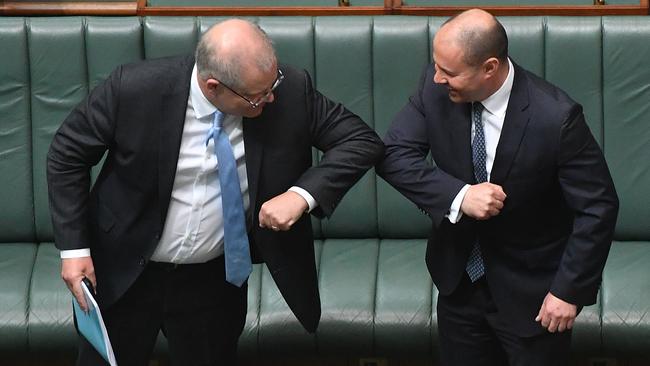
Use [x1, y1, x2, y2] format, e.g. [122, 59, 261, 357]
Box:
[77, 256, 247, 366]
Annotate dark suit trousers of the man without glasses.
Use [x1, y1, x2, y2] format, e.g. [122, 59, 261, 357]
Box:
[437, 275, 571, 366]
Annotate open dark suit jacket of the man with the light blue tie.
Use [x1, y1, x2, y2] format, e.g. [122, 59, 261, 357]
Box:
[47, 57, 383, 331]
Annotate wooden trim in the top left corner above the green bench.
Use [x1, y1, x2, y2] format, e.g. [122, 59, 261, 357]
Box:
[2, 1, 137, 15]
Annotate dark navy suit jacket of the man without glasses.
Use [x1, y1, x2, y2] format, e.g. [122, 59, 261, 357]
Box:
[378, 61, 618, 335]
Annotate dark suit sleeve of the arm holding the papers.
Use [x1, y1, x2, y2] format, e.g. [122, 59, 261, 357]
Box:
[47, 68, 121, 250]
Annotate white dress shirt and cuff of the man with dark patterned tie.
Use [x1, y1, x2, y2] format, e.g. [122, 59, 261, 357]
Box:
[447, 58, 515, 224]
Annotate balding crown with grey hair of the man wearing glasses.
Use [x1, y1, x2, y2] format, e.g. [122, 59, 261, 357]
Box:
[196, 19, 277, 88]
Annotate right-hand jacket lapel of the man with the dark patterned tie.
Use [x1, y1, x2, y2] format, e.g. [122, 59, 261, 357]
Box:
[490, 65, 530, 185]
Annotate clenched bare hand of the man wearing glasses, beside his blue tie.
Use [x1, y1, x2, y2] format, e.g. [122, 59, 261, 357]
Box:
[259, 191, 309, 231]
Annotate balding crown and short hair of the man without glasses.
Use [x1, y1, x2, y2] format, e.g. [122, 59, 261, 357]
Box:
[436, 9, 508, 66]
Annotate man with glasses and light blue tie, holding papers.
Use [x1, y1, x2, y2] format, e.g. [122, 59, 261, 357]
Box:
[47, 20, 383, 366]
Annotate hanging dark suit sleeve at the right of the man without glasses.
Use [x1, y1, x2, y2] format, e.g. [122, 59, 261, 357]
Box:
[551, 106, 618, 305]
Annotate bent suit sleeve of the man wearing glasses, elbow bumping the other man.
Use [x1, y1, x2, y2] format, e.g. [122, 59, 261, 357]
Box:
[295, 72, 384, 217]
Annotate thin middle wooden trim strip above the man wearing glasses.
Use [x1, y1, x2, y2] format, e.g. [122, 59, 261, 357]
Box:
[138, 6, 392, 16]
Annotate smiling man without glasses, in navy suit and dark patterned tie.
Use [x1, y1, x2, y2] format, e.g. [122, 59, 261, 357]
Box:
[377, 9, 618, 366]
